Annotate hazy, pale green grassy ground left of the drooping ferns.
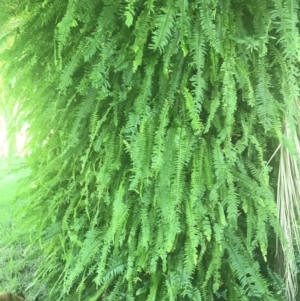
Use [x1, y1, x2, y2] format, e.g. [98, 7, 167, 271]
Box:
[0, 157, 36, 300]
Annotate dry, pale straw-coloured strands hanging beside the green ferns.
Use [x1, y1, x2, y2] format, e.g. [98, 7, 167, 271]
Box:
[276, 115, 300, 301]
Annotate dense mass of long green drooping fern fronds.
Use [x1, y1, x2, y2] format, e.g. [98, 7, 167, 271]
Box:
[0, 0, 300, 301]
